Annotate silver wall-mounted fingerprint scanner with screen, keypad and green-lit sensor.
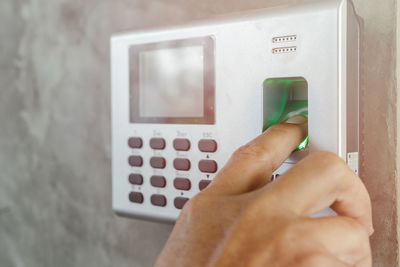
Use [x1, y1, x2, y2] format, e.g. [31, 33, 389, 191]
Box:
[111, 0, 359, 222]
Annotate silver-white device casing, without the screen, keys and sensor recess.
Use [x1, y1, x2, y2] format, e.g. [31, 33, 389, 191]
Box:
[111, 0, 359, 221]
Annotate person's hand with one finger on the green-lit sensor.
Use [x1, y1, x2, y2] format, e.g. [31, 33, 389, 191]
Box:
[155, 118, 373, 267]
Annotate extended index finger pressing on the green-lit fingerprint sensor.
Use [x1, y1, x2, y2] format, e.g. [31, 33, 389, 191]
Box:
[207, 117, 307, 194]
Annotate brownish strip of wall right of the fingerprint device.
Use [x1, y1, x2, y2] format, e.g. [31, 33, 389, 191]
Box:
[356, 1, 399, 266]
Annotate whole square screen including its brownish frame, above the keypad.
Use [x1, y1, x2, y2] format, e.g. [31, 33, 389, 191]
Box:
[131, 37, 215, 124]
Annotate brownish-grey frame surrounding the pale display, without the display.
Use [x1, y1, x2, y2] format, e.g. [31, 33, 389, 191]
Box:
[129, 36, 215, 124]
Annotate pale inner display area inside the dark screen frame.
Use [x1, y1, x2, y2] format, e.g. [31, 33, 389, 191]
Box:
[139, 46, 204, 118]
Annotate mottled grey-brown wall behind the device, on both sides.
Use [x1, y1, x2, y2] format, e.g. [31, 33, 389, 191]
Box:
[0, 0, 398, 267]
